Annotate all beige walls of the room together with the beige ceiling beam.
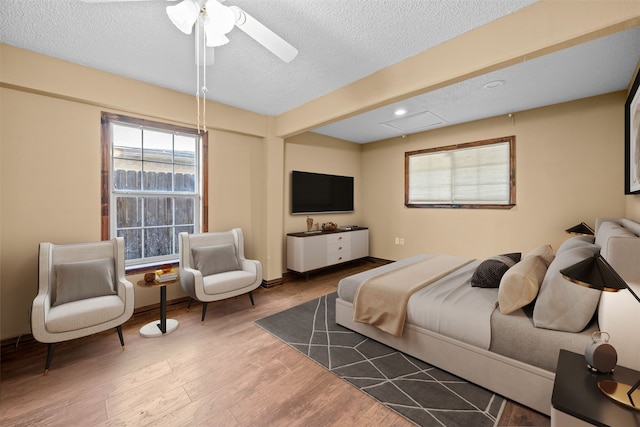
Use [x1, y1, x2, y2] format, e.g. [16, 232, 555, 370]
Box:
[0, 0, 640, 339]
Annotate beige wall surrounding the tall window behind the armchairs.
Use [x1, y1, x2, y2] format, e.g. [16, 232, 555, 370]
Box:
[0, 45, 270, 339]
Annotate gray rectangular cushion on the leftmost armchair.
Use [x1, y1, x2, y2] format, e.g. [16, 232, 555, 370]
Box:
[52, 258, 116, 307]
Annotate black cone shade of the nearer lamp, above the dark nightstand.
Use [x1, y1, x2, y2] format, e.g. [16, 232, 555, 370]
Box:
[560, 253, 628, 292]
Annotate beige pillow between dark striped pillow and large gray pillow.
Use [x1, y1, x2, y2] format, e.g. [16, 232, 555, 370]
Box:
[498, 255, 547, 314]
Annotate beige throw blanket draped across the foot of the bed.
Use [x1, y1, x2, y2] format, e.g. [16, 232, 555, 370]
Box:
[353, 255, 472, 336]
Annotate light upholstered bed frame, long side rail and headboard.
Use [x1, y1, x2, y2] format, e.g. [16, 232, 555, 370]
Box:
[336, 219, 640, 415]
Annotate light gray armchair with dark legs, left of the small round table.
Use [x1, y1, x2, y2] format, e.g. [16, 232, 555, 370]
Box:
[31, 237, 134, 375]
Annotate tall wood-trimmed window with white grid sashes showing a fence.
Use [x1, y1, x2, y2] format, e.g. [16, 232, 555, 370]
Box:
[102, 113, 206, 267]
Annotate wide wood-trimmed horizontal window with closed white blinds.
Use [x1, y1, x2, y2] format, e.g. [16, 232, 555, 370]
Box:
[405, 136, 516, 209]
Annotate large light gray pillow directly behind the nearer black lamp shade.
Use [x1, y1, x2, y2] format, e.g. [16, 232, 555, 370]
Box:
[533, 245, 601, 332]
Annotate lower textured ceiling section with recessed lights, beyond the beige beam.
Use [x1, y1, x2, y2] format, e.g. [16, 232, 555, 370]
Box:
[315, 27, 640, 143]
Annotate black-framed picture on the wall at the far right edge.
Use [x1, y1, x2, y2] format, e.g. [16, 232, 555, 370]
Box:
[624, 73, 640, 194]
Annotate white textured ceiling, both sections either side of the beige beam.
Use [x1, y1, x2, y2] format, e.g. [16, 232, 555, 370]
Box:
[0, 0, 640, 143]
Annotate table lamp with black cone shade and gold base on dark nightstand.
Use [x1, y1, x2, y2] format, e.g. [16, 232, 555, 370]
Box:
[560, 254, 640, 411]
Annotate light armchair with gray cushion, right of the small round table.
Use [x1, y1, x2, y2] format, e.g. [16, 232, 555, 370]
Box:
[179, 228, 262, 322]
